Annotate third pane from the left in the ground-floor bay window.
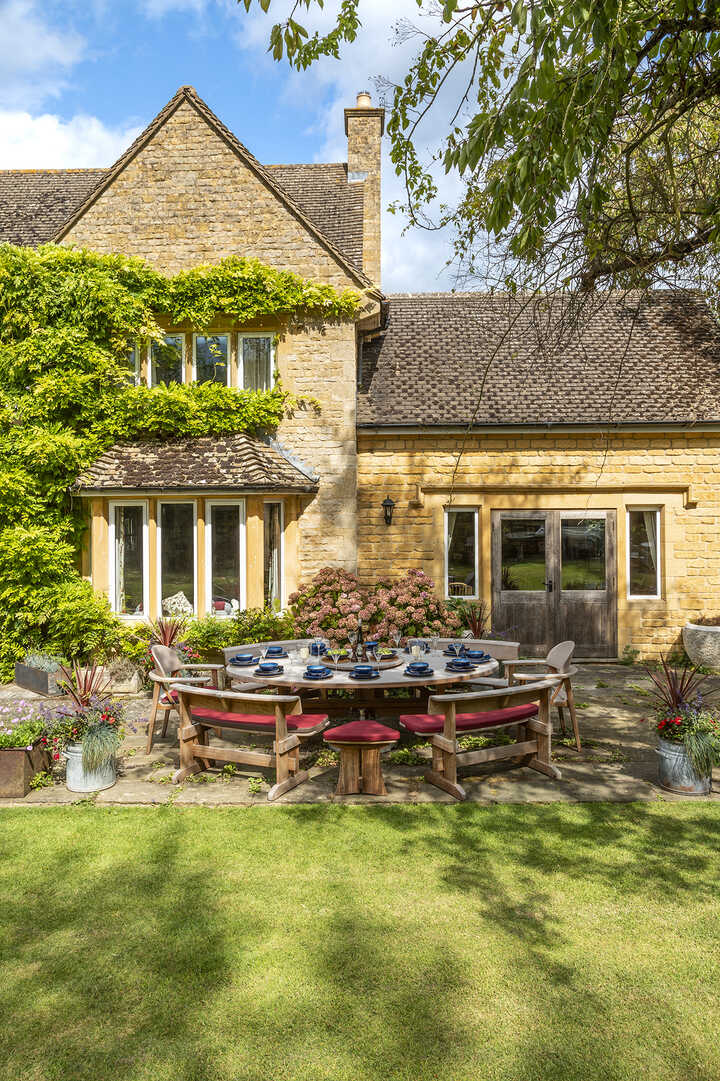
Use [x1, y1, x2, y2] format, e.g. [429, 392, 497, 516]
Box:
[205, 501, 245, 615]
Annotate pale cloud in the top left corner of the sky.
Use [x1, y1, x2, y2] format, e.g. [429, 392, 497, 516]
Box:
[0, 0, 85, 108]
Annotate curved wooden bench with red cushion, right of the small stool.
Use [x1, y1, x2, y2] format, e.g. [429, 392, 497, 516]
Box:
[400, 679, 560, 800]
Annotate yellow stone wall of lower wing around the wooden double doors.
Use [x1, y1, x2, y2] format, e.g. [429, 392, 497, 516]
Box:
[358, 432, 720, 656]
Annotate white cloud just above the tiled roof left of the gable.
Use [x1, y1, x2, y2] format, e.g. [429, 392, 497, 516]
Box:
[0, 109, 142, 169]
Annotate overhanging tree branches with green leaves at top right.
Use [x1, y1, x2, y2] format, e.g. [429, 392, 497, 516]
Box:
[241, 0, 720, 295]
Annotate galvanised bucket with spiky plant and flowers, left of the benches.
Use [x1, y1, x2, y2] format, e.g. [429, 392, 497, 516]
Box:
[48, 664, 124, 792]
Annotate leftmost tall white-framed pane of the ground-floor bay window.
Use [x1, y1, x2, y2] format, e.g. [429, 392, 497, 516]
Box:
[108, 503, 149, 616]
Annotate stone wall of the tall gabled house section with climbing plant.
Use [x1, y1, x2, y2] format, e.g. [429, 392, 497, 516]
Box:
[64, 103, 365, 578]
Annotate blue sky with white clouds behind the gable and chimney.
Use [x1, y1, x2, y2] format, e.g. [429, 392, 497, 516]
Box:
[0, 0, 460, 292]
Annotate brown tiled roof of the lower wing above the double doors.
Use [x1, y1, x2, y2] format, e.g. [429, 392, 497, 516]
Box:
[358, 291, 720, 427]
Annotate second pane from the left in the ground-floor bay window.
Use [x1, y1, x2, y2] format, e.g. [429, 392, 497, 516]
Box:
[158, 503, 197, 615]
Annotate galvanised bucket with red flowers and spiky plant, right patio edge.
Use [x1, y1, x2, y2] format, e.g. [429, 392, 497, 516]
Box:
[645, 656, 720, 796]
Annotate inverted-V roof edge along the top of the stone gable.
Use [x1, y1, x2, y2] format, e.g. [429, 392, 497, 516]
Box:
[53, 86, 375, 290]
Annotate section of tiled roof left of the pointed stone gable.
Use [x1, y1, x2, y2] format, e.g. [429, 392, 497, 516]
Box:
[0, 169, 107, 246]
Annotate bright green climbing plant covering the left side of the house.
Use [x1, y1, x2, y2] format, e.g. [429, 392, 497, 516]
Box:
[0, 244, 360, 679]
